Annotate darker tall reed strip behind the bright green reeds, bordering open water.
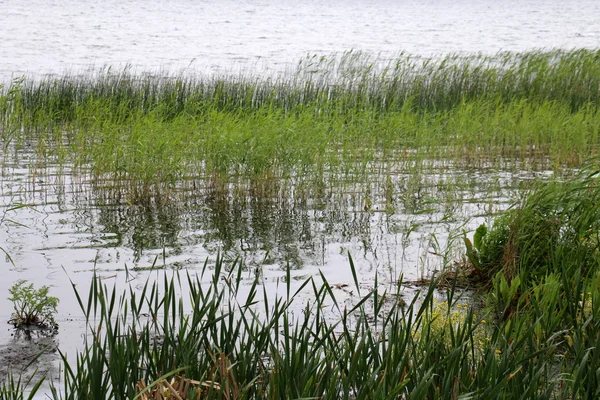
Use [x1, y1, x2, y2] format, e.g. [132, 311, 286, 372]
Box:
[3, 49, 600, 122]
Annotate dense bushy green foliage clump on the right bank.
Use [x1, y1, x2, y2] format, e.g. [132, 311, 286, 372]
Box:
[463, 167, 600, 351]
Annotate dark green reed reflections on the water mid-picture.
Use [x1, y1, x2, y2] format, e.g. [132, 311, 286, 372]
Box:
[89, 174, 372, 268]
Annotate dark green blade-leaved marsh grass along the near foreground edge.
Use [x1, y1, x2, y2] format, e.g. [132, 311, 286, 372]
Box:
[4, 241, 600, 399]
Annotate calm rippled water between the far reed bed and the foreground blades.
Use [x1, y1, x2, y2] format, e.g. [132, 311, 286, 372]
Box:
[0, 151, 548, 384]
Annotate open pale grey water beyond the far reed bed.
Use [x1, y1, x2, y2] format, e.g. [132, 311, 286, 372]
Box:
[0, 0, 600, 82]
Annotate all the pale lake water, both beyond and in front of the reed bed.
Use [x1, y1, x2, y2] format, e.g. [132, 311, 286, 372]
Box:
[0, 0, 600, 390]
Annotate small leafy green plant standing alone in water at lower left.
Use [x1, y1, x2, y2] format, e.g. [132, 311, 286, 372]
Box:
[8, 280, 58, 333]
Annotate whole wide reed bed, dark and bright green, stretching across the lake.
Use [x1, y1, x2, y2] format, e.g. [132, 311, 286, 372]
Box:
[0, 50, 600, 200]
